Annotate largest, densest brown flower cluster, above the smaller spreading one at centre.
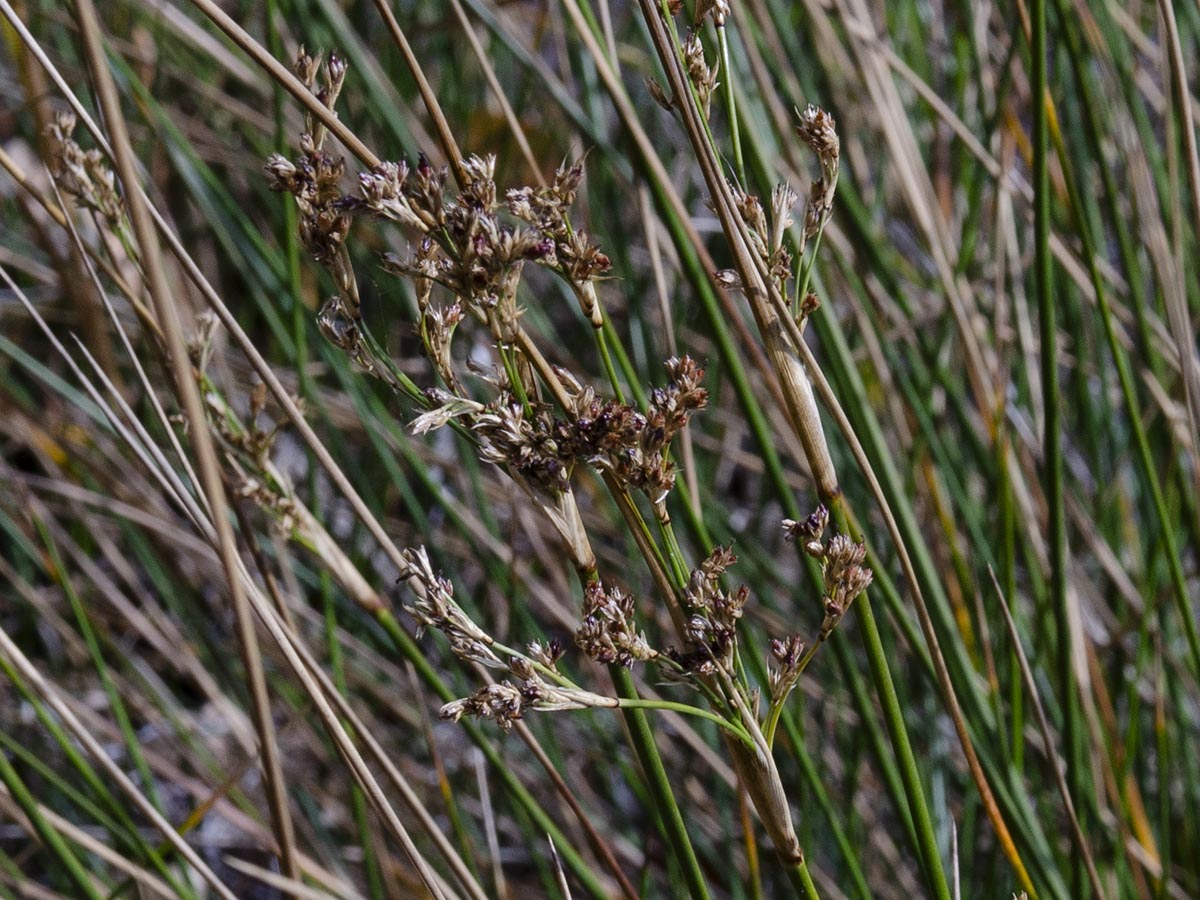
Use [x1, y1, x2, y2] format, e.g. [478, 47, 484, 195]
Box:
[266, 54, 707, 528]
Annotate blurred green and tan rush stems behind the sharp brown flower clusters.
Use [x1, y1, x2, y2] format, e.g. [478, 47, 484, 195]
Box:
[0, 0, 1200, 900]
